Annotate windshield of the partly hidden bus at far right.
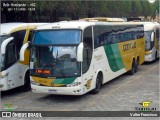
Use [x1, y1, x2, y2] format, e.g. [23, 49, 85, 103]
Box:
[144, 31, 152, 50]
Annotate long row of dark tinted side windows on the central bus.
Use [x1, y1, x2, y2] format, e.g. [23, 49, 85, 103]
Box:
[94, 25, 144, 48]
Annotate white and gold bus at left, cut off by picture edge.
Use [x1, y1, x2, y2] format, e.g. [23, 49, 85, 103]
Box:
[0, 23, 45, 91]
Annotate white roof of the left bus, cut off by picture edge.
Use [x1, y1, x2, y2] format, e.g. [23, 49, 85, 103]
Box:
[0, 23, 47, 35]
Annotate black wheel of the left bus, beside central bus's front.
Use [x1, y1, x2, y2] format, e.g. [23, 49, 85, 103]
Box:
[20, 71, 31, 92]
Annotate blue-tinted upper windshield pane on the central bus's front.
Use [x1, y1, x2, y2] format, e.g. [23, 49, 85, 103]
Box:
[33, 29, 81, 45]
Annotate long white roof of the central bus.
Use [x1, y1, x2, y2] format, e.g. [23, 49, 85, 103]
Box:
[36, 20, 142, 30]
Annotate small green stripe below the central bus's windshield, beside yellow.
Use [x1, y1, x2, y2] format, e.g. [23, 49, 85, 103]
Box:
[54, 77, 76, 84]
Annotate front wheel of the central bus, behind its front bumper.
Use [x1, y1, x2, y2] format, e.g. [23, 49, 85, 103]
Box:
[92, 74, 102, 94]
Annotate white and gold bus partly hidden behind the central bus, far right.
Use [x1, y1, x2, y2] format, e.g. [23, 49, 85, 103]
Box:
[143, 22, 160, 62]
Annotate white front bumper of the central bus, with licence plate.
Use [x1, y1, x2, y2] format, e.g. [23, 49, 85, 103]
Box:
[31, 84, 83, 95]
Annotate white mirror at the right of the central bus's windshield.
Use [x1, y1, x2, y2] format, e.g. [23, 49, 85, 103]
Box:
[77, 42, 84, 62]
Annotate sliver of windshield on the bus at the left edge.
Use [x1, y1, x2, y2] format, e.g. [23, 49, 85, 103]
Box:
[0, 35, 10, 71]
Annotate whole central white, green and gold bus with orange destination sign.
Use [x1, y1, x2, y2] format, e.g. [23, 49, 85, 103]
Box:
[20, 20, 145, 95]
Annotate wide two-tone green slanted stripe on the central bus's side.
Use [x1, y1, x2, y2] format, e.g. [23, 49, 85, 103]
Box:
[104, 44, 124, 72]
